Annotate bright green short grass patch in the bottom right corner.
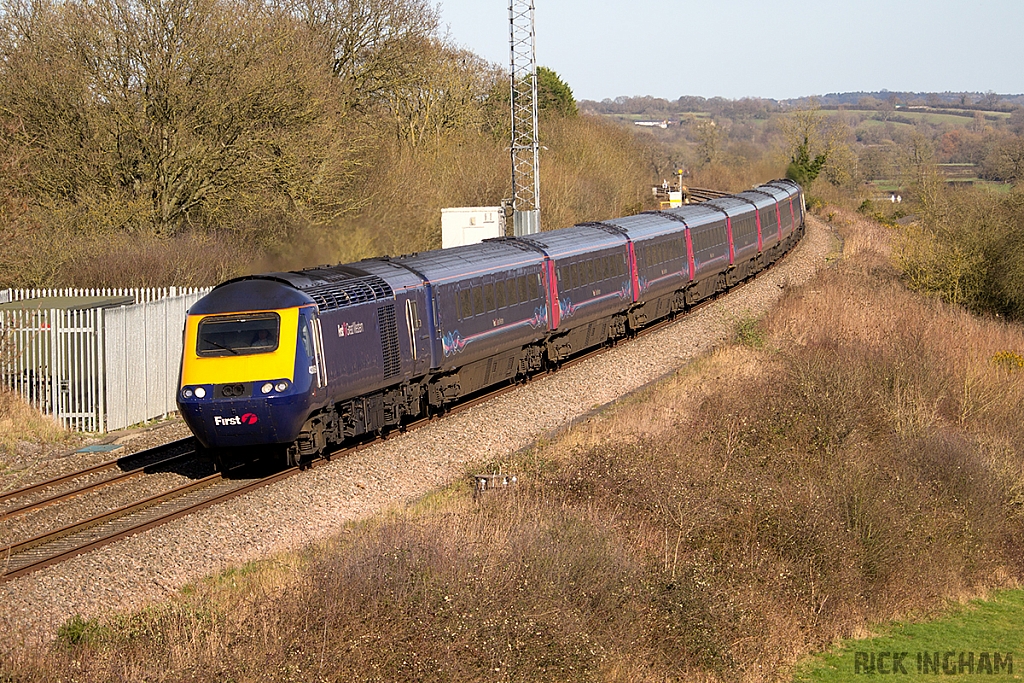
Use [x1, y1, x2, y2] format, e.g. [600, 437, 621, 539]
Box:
[794, 590, 1024, 683]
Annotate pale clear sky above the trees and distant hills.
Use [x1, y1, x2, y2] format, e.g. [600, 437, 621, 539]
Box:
[434, 0, 1024, 100]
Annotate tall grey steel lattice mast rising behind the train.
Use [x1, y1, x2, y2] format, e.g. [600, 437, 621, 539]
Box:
[509, 0, 541, 237]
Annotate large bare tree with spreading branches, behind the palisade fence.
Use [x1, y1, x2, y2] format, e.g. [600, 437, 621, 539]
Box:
[0, 0, 355, 234]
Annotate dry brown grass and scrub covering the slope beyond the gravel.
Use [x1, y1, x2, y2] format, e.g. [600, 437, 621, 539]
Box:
[6, 210, 1024, 682]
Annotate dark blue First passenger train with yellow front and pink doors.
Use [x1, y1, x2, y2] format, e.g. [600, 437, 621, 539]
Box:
[177, 180, 806, 466]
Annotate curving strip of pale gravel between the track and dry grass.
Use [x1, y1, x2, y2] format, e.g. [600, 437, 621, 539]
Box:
[0, 217, 834, 647]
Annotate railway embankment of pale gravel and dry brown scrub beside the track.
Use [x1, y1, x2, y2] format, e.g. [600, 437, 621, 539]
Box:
[8, 212, 1024, 681]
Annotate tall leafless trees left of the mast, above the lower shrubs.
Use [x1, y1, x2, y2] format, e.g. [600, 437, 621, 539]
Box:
[0, 0, 492, 240]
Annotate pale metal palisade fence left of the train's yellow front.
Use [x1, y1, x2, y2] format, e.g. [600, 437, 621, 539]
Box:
[0, 288, 209, 432]
